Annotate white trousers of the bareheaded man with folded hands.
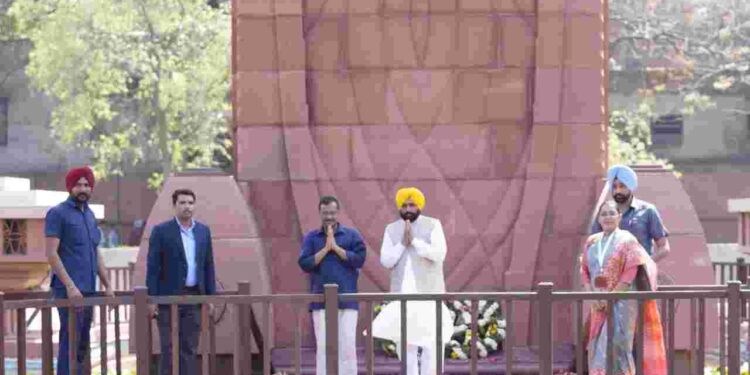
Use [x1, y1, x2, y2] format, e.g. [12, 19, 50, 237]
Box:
[312, 309, 359, 375]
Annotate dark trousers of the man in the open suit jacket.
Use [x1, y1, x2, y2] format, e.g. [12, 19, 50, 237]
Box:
[156, 288, 201, 375]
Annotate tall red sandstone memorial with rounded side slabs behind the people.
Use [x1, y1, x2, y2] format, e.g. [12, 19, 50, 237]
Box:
[0, 0, 732, 373]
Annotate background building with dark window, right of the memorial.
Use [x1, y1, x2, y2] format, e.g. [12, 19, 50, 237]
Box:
[609, 70, 750, 243]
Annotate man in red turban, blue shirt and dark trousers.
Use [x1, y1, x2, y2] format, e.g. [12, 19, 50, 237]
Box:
[44, 167, 114, 375]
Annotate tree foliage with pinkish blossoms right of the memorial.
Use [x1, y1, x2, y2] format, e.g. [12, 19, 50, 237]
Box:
[609, 0, 750, 169]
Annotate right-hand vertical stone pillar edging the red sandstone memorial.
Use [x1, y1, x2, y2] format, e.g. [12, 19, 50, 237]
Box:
[504, 0, 608, 340]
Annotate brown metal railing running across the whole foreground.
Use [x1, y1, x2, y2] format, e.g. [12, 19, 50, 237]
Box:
[0, 281, 750, 375]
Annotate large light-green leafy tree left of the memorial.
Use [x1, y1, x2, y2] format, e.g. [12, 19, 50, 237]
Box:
[9, 0, 231, 187]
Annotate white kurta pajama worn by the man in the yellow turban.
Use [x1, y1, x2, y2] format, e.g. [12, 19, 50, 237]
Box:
[372, 215, 453, 375]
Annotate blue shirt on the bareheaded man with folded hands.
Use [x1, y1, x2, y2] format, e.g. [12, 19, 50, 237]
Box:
[299, 224, 366, 310]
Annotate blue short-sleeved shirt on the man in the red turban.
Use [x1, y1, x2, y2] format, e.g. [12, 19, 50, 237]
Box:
[44, 197, 101, 293]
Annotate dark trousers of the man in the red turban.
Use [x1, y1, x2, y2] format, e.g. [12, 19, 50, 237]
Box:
[52, 289, 94, 375]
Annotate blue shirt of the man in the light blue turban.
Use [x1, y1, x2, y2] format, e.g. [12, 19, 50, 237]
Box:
[591, 197, 669, 255]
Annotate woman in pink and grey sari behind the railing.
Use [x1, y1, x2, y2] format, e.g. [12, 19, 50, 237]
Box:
[581, 200, 667, 375]
